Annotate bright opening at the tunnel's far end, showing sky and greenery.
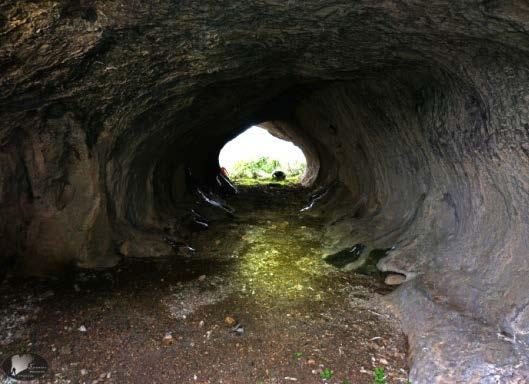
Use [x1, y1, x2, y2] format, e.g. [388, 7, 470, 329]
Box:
[219, 125, 307, 184]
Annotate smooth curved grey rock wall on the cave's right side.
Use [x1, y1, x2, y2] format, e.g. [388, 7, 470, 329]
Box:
[290, 71, 529, 382]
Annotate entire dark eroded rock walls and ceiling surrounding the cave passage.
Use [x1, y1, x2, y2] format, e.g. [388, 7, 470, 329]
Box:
[0, 0, 529, 383]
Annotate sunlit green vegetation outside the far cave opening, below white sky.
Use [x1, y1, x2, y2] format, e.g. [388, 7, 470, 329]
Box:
[229, 157, 306, 185]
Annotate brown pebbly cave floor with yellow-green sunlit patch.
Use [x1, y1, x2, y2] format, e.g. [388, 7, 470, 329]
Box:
[0, 186, 407, 384]
